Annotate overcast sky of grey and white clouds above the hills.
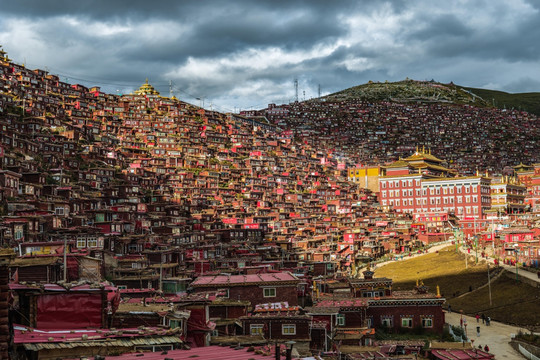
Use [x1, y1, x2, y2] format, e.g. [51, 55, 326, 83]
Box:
[0, 0, 540, 111]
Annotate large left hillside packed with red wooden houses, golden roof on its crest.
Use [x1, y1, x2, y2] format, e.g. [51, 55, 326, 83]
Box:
[0, 54, 384, 251]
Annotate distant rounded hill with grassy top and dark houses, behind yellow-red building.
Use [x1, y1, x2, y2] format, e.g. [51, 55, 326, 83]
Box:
[260, 80, 540, 175]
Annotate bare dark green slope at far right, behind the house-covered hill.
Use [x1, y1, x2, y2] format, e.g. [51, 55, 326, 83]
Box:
[463, 87, 540, 115]
